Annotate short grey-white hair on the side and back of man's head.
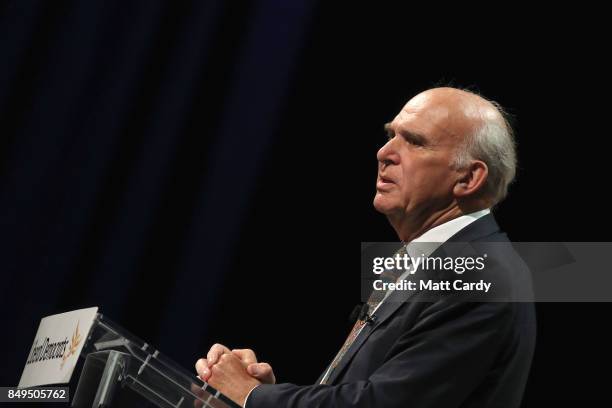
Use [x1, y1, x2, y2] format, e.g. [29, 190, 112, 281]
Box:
[453, 101, 516, 205]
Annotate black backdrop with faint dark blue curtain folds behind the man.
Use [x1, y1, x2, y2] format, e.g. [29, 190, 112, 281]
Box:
[0, 0, 612, 407]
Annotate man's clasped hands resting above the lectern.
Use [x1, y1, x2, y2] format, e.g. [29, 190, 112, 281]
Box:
[195, 344, 276, 407]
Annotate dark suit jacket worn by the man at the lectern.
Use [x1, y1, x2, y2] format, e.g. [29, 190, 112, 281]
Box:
[246, 214, 536, 408]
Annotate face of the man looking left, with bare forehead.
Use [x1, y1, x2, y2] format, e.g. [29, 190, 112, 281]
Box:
[374, 92, 471, 217]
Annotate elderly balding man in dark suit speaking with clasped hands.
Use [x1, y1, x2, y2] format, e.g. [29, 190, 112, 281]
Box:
[196, 88, 535, 408]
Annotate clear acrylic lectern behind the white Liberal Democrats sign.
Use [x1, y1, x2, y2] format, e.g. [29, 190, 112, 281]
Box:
[71, 313, 238, 408]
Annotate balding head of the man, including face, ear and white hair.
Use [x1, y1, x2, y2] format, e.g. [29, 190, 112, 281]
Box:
[374, 87, 516, 241]
